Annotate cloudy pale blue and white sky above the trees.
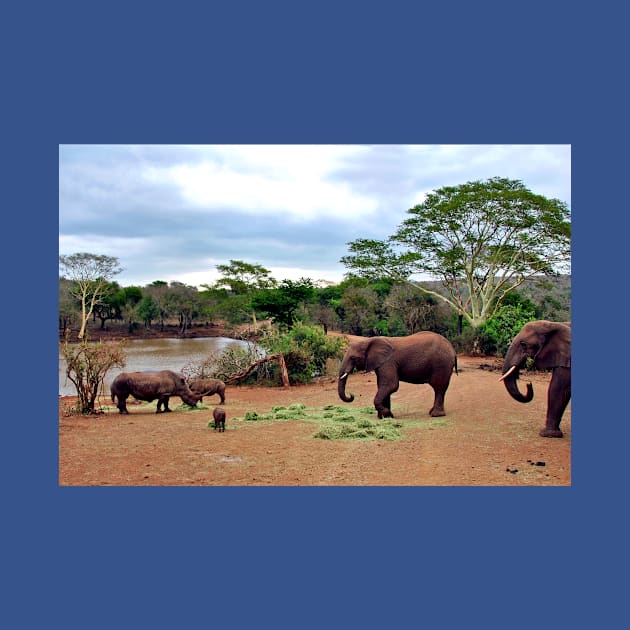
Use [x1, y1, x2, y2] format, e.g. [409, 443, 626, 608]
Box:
[59, 145, 571, 286]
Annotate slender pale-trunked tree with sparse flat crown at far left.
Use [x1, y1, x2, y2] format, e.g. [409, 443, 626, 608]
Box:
[59, 252, 122, 339]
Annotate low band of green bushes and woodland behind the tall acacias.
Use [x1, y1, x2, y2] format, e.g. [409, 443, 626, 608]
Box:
[59, 276, 571, 354]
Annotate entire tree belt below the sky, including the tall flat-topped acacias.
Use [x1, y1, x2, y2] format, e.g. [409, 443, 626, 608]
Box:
[59, 177, 571, 353]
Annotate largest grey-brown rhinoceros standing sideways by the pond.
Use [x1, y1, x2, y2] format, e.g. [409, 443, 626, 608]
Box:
[110, 370, 200, 413]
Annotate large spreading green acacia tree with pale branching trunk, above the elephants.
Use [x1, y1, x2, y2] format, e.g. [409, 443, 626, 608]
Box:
[341, 177, 571, 328]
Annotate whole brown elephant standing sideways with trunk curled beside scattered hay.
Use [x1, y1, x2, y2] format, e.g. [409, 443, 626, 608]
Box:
[338, 331, 457, 418]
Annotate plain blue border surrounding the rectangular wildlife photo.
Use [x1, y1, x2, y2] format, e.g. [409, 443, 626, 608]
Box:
[2, 1, 628, 629]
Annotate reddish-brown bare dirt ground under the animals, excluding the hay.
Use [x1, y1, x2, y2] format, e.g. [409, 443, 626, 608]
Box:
[59, 356, 571, 486]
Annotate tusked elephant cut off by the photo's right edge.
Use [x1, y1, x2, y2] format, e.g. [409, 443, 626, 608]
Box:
[499, 319, 571, 437]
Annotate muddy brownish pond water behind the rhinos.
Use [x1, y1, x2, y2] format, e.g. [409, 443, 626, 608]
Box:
[59, 337, 256, 396]
